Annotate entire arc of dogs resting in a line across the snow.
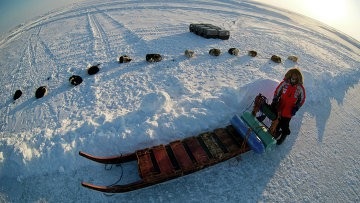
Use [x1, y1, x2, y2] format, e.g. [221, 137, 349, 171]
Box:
[13, 51, 298, 101]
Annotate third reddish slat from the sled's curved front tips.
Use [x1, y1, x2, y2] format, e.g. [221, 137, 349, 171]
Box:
[170, 140, 194, 171]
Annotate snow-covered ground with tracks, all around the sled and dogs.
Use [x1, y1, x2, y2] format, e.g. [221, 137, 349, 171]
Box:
[0, 0, 360, 202]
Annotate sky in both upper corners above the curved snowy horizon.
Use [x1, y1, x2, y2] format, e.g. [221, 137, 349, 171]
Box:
[0, 0, 360, 42]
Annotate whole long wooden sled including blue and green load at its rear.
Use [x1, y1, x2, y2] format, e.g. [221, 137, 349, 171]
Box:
[79, 95, 276, 193]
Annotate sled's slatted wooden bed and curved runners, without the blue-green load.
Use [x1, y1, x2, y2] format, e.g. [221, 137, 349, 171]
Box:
[79, 125, 250, 193]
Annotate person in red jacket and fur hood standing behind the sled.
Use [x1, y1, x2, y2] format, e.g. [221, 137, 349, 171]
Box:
[271, 68, 306, 145]
